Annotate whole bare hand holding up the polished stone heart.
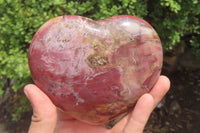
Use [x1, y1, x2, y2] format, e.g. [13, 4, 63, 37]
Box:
[24, 76, 170, 133]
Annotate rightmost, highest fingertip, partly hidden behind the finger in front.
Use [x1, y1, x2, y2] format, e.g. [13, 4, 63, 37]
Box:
[150, 76, 170, 107]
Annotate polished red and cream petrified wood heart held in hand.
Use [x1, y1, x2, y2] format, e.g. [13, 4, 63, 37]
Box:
[29, 15, 163, 125]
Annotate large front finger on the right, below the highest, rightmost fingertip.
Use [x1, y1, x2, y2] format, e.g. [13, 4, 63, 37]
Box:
[120, 94, 154, 133]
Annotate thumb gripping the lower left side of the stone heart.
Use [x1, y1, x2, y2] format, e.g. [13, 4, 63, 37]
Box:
[24, 84, 57, 133]
